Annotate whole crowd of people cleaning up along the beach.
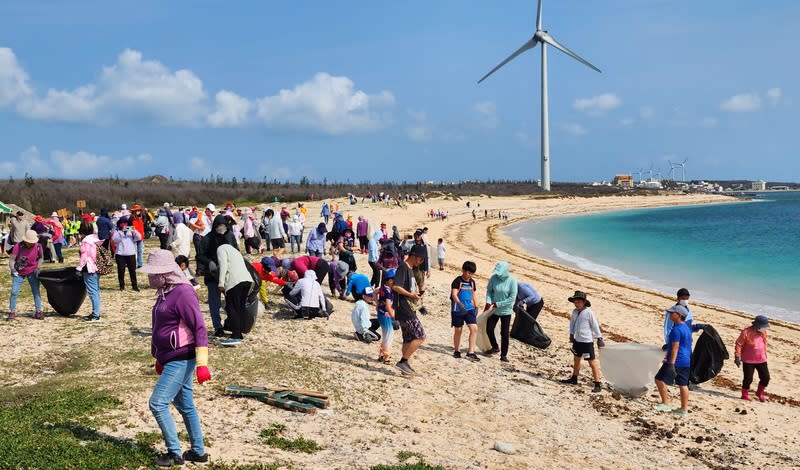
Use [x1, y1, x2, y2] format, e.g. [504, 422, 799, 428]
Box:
[3, 195, 769, 466]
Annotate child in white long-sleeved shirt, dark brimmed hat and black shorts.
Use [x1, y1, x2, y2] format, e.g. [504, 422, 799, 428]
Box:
[561, 290, 604, 393]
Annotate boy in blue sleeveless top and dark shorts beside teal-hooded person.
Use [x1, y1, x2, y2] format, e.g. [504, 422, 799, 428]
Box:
[450, 260, 480, 362]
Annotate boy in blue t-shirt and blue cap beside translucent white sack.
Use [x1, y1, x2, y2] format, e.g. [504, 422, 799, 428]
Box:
[655, 304, 692, 416]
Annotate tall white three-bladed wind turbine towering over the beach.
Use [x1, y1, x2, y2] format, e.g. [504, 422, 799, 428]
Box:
[478, 0, 602, 191]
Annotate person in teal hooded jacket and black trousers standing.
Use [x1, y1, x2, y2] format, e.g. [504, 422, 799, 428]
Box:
[483, 261, 517, 362]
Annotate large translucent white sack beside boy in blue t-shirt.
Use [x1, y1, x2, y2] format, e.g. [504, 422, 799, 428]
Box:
[600, 343, 664, 397]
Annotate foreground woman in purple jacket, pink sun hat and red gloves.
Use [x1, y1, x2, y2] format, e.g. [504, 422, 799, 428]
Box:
[142, 250, 211, 467]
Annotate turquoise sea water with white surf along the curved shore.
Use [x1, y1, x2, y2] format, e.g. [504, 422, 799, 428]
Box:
[507, 192, 800, 323]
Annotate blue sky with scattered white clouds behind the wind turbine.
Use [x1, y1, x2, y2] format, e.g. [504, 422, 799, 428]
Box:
[0, 0, 800, 182]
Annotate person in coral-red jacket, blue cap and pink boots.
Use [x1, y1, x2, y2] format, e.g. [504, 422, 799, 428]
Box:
[733, 315, 769, 403]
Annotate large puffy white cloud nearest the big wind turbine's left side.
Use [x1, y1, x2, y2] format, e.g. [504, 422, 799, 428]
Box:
[257, 72, 394, 135]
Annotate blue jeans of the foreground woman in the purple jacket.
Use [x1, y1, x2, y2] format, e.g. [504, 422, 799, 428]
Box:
[150, 359, 206, 455]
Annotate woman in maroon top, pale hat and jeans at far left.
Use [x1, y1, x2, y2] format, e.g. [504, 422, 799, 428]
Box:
[6, 229, 44, 320]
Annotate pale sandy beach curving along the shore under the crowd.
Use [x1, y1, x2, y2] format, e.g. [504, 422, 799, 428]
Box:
[0, 195, 800, 469]
